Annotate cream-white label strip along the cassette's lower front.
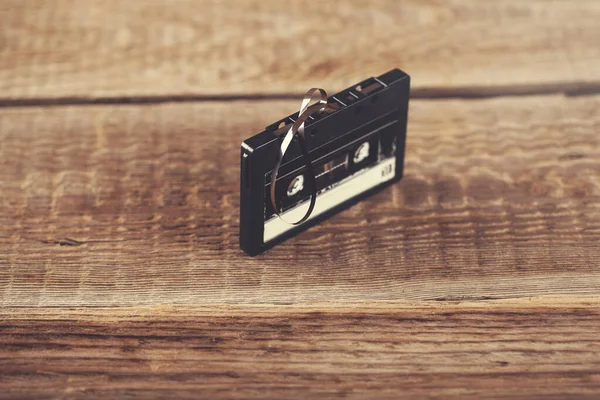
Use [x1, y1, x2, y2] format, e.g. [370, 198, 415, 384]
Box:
[263, 157, 396, 243]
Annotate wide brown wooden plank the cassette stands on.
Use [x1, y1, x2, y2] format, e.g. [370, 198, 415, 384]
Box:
[0, 96, 600, 307]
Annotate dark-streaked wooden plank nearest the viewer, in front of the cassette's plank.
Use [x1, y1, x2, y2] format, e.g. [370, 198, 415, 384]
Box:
[0, 297, 600, 399]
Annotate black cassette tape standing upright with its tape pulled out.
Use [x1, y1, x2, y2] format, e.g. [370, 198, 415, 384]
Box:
[240, 69, 410, 256]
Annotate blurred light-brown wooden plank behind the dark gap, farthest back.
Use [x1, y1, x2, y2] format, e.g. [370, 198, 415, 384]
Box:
[0, 0, 600, 100]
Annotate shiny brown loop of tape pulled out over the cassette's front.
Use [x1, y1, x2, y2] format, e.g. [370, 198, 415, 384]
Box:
[270, 88, 327, 225]
